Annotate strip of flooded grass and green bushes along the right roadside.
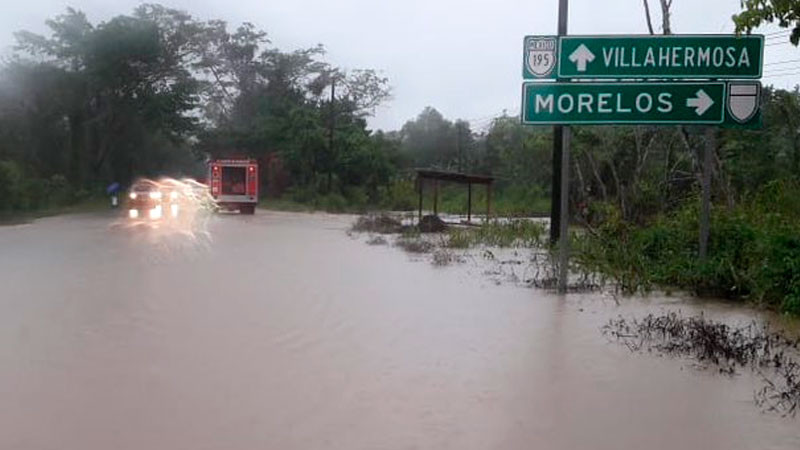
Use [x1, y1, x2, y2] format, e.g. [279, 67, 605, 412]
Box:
[353, 181, 800, 315]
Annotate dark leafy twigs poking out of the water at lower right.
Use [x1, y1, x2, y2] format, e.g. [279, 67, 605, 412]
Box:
[602, 312, 800, 416]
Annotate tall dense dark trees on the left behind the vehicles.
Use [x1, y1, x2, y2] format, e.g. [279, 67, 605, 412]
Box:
[0, 4, 397, 210]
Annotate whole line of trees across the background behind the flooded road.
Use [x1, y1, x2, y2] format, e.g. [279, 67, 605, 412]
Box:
[0, 4, 800, 222]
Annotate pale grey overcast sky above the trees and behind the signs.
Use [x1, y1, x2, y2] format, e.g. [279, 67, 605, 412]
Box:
[0, 0, 800, 130]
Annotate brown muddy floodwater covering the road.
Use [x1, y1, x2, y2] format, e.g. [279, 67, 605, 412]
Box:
[0, 213, 800, 450]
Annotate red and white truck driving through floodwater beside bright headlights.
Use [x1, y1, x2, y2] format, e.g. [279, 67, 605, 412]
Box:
[208, 158, 259, 214]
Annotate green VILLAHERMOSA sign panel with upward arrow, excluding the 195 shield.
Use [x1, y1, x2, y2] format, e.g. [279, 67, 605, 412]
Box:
[558, 35, 764, 79]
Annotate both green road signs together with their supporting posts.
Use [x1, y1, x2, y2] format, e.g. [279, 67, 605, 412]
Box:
[521, 29, 764, 292]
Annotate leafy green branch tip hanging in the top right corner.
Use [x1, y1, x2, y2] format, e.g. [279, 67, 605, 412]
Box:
[733, 0, 800, 46]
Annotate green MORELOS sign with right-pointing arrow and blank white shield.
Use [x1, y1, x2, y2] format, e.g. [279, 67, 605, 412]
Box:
[522, 82, 748, 125]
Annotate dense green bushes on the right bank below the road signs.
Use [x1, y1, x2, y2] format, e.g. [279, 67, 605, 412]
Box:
[576, 181, 800, 314]
